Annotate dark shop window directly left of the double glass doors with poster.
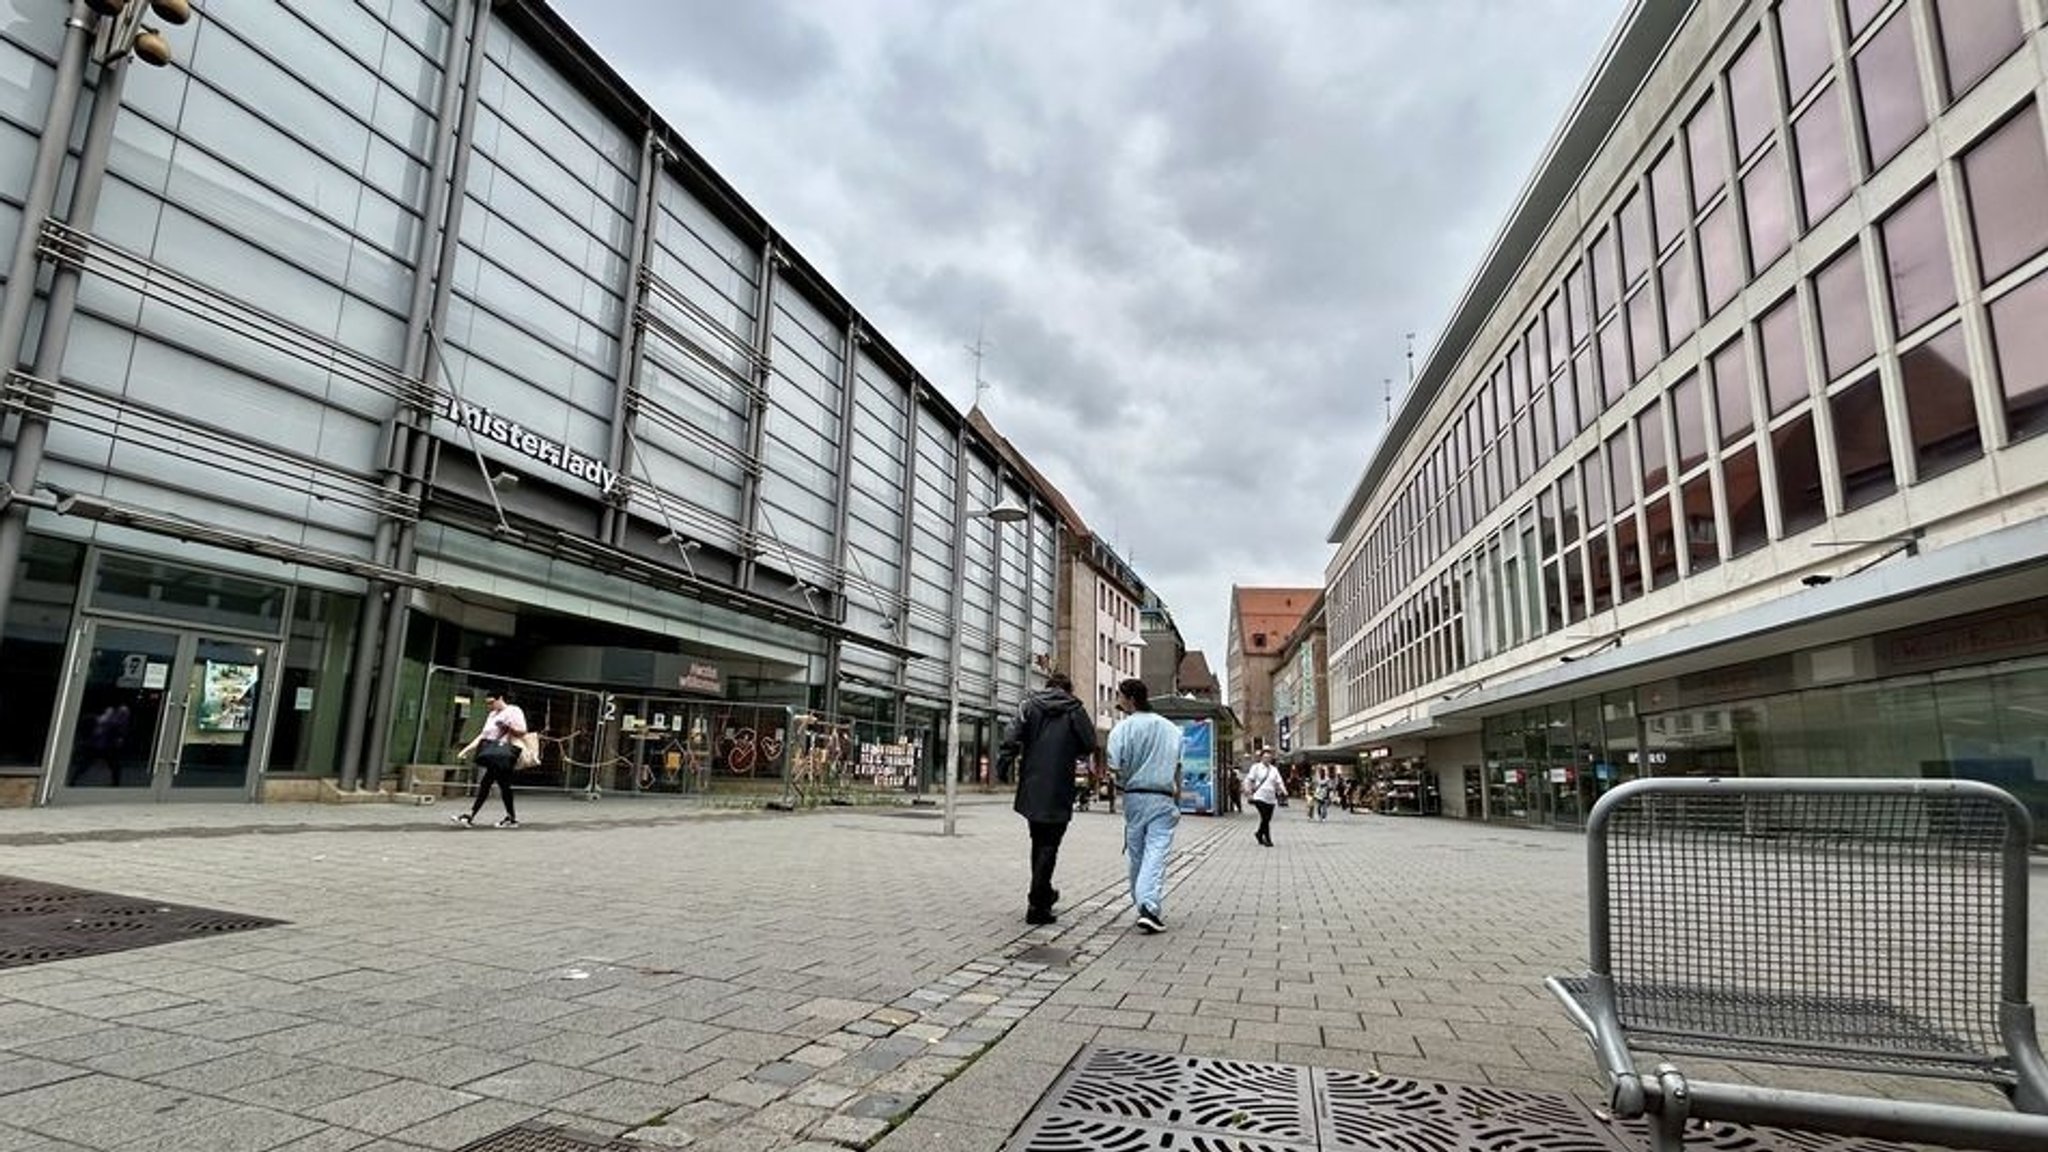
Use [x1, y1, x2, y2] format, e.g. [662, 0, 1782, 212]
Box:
[0, 535, 86, 769]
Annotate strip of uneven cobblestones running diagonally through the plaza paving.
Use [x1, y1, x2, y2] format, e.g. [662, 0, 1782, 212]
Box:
[621, 822, 1231, 1152]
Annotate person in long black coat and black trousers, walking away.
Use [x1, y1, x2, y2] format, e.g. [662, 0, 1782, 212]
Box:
[1001, 672, 1096, 924]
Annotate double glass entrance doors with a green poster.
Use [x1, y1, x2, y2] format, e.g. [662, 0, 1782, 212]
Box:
[51, 621, 270, 801]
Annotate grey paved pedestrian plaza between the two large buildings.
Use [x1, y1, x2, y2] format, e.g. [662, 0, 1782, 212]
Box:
[0, 795, 2048, 1152]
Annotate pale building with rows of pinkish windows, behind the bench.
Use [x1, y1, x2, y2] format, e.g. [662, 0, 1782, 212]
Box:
[1327, 0, 2048, 822]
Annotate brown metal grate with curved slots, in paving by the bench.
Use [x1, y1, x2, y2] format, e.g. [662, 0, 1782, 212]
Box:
[1006, 1047, 1907, 1152]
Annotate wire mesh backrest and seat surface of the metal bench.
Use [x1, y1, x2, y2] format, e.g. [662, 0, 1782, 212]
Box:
[1606, 791, 2011, 1078]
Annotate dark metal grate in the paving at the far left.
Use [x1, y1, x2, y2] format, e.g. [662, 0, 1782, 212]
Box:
[0, 875, 283, 968]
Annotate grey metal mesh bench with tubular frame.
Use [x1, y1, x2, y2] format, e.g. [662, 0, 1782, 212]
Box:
[1548, 779, 2048, 1152]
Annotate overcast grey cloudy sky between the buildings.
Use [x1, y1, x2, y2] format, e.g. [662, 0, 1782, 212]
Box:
[553, 0, 1624, 676]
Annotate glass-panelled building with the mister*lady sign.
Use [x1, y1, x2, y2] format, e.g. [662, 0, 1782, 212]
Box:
[0, 0, 1061, 801]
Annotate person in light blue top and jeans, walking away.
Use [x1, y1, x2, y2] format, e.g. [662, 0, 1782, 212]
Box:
[1108, 681, 1180, 933]
